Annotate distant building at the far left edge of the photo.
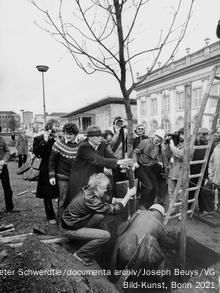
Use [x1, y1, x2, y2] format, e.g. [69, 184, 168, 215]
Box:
[0, 111, 20, 132]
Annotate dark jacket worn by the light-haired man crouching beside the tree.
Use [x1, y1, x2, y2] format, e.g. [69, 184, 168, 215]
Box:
[62, 187, 124, 230]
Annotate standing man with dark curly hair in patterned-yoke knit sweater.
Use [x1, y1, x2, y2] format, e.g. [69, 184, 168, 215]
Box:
[49, 123, 79, 218]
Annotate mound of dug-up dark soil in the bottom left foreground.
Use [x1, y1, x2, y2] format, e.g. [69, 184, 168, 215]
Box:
[0, 236, 118, 293]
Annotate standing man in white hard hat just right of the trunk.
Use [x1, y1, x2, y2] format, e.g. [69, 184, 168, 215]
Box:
[133, 129, 165, 208]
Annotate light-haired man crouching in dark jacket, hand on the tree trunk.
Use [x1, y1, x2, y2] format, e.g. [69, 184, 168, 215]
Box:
[61, 173, 136, 265]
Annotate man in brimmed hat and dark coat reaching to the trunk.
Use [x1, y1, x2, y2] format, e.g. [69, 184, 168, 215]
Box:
[65, 125, 133, 206]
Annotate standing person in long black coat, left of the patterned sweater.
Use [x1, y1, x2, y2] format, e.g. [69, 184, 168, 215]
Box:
[33, 119, 58, 224]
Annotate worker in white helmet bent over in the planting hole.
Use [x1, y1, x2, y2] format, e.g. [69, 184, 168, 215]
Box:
[112, 204, 166, 269]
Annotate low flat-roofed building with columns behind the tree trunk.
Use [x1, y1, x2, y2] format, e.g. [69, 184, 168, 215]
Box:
[63, 97, 137, 132]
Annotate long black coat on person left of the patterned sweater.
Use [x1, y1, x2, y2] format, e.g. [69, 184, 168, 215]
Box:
[33, 135, 58, 198]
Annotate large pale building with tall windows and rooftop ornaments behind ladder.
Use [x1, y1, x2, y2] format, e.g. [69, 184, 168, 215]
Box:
[136, 41, 220, 133]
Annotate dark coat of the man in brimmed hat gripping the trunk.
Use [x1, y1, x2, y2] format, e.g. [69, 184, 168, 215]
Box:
[65, 140, 118, 206]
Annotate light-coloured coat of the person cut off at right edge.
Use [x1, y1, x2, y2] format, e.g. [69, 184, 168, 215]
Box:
[208, 144, 220, 185]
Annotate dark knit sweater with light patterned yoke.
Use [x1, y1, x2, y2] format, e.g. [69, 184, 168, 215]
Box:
[49, 138, 78, 181]
